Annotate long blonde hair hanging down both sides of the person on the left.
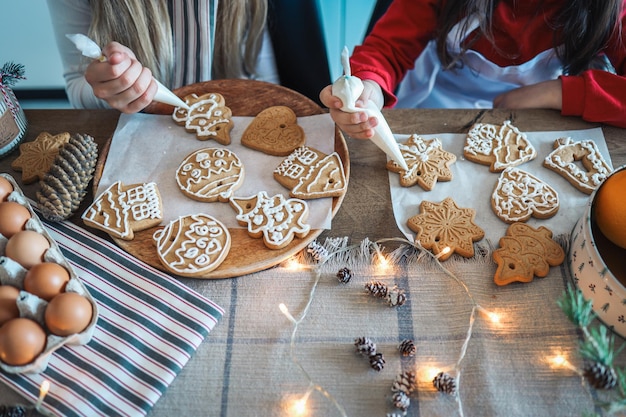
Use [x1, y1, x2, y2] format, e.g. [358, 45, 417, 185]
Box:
[89, 0, 267, 85]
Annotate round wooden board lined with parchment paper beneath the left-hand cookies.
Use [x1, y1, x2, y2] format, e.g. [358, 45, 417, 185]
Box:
[92, 80, 350, 279]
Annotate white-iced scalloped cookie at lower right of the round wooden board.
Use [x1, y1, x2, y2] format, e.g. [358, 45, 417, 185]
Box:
[230, 191, 311, 249]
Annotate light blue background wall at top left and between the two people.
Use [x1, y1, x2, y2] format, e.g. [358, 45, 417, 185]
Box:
[0, 0, 375, 89]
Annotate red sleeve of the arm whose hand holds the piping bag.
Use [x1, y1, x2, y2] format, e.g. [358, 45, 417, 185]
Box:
[350, 0, 438, 106]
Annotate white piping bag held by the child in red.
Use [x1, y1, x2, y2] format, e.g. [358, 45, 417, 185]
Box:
[332, 46, 409, 171]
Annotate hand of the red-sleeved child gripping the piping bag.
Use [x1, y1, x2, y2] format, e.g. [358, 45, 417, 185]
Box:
[320, 80, 383, 139]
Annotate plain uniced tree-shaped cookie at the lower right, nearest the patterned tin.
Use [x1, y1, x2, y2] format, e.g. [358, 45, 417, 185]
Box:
[493, 223, 565, 285]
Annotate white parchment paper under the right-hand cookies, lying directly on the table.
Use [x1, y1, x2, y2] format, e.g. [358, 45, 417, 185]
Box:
[389, 128, 611, 247]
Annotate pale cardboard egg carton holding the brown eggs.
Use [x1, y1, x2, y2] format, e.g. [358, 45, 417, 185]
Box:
[0, 173, 98, 374]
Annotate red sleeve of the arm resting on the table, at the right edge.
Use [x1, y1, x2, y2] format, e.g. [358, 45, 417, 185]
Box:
[561, 0, 626, 128]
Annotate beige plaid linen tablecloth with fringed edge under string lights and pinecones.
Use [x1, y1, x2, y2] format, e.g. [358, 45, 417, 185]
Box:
[145, 239, 596, 417]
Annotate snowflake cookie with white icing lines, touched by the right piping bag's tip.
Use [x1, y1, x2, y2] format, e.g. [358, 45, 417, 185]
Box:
[387, 134, 456, 191]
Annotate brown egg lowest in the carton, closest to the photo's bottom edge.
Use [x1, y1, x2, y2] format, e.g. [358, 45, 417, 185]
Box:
[0, 317, 46, 366]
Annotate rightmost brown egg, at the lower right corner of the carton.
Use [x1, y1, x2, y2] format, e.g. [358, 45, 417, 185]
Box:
[44, 292, 93, 336]
